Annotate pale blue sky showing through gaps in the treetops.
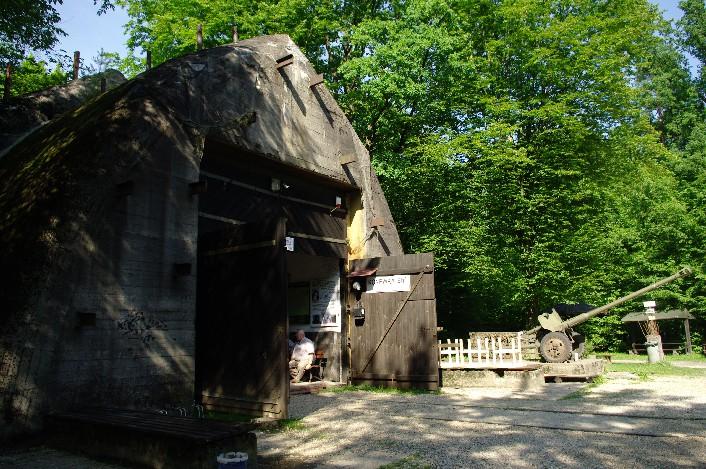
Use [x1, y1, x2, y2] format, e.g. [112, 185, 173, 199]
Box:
[51, 0, 694, 72]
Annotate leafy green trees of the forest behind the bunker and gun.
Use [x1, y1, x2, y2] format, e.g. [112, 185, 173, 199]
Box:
[0, 0, 706, 350]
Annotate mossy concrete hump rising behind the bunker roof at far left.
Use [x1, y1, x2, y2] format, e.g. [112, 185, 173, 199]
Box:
[0, 70, 125, 153]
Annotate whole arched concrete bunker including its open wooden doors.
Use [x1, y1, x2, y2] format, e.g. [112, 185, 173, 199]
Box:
[0, 36, 438, 437]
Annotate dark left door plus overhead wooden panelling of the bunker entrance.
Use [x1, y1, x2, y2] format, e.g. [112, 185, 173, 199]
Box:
[196, 140, 356, 418]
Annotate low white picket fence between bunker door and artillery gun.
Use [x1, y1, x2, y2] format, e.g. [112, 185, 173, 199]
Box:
[439, 332, 525, 368]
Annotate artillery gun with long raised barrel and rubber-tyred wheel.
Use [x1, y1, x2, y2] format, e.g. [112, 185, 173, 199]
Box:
[523, 267, 692, 363]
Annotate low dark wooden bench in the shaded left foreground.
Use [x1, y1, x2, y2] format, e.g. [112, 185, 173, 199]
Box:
[46, 408, 257, 469]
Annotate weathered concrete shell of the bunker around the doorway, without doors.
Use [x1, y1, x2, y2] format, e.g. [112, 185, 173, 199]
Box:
[0, 36, 402, 439]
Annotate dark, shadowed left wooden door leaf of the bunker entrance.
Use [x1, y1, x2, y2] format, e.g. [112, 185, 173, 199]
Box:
[196, 219, 289, 418]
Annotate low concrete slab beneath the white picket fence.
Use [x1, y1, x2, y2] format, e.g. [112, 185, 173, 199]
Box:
[441, 369, 545, 391]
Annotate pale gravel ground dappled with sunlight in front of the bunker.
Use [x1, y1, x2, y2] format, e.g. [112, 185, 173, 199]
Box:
[0, 373, 706, 469]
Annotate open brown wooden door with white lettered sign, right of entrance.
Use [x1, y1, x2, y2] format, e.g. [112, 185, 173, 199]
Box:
[348, 254, 439, 389]
